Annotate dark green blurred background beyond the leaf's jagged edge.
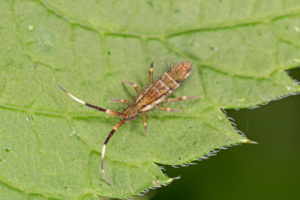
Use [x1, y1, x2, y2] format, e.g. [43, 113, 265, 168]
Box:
[152, 68, 300, 200]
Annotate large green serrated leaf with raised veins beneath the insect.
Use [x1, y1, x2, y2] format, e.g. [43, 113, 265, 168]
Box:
[0, 0, 300, 200]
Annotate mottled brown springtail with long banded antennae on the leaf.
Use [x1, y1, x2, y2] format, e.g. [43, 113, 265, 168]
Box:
[57, 62, 199, 184]
